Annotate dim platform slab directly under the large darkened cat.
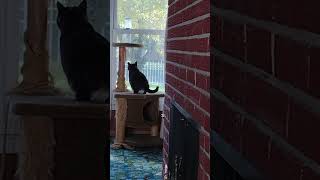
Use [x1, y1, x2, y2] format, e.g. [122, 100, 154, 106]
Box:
[10, 96, 109, 119]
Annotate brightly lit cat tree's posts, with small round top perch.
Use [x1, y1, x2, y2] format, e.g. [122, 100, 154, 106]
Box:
[112, 43, 142, 148]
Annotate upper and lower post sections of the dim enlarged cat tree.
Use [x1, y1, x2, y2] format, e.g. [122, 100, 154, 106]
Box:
[11, 0, 59, 180]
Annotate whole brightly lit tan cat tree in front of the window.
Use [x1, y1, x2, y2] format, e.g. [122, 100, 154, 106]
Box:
[112, 43, 164, 149]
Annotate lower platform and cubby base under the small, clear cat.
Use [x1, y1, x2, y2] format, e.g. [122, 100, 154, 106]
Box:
[112, 92, 164, 149]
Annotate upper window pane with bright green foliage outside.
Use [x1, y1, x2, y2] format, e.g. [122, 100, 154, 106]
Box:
[115, 0, 168, 29]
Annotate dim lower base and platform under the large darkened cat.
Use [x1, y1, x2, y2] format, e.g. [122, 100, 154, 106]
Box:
[12, 96, 109, 180]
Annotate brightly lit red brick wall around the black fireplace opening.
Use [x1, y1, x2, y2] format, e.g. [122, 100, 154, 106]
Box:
[163, 0, 210, 180]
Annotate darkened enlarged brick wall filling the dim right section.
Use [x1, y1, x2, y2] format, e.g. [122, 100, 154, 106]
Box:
[211, 0, 320, 180]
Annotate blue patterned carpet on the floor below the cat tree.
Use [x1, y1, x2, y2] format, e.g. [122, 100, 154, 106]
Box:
[110, 144, 162, 180]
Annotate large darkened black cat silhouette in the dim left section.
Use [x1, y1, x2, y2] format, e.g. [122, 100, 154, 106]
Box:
[57, 0, 110, 101]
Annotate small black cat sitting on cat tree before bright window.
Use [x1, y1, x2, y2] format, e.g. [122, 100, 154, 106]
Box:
[128, 62, 159, 94]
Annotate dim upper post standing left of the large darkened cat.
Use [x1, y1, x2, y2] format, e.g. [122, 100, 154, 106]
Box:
[12, 0, 58, 95]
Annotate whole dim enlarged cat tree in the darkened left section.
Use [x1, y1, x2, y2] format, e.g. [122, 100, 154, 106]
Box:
[0, 0, 109, 180]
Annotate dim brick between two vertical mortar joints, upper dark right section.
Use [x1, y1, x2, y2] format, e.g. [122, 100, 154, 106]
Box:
[246, 26, 272, 74]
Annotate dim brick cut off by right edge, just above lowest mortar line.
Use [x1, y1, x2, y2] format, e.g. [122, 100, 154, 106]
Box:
[288, 102, 320, 163]
